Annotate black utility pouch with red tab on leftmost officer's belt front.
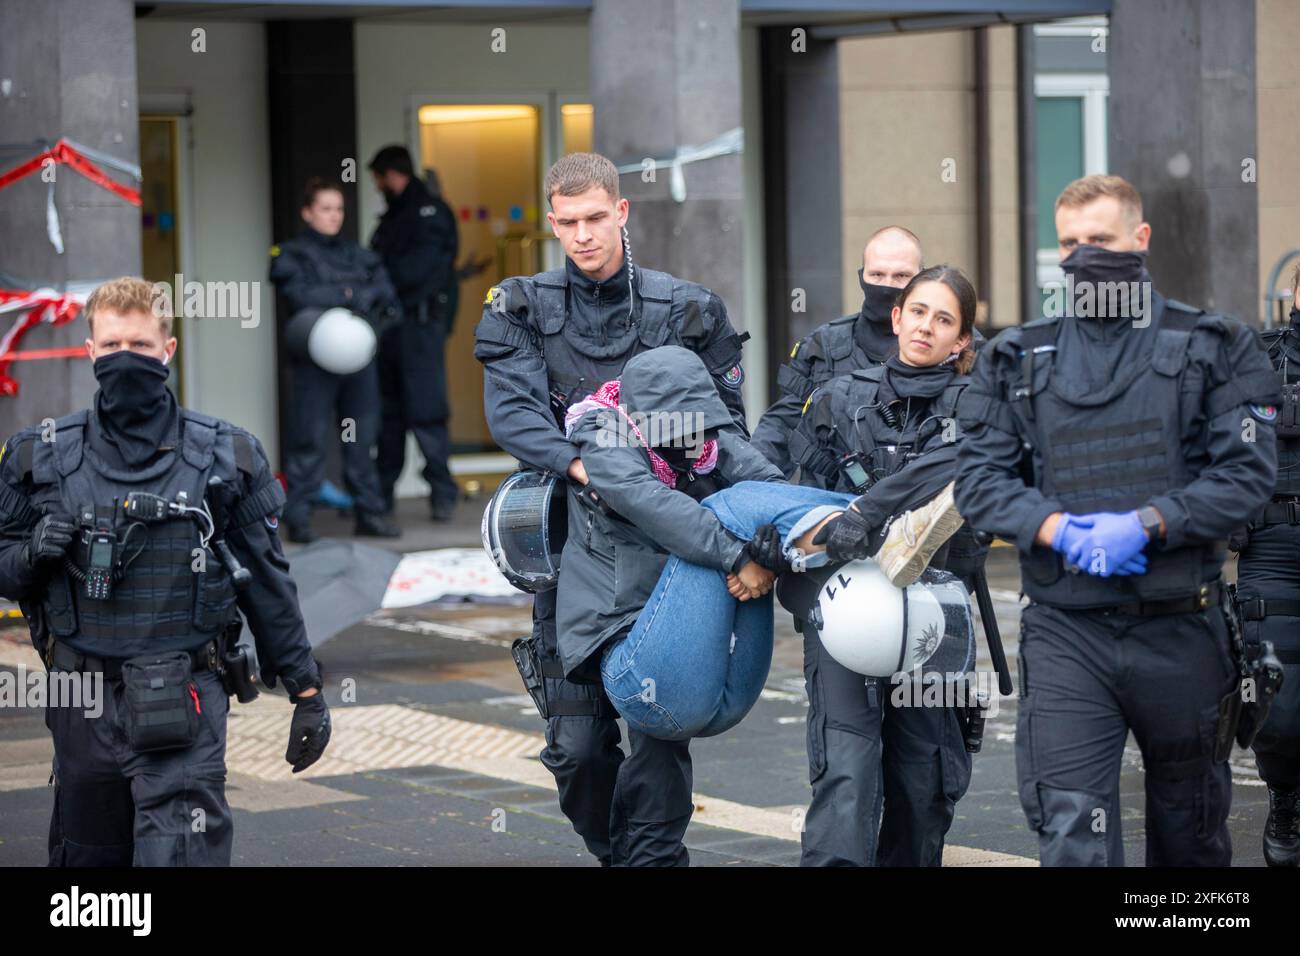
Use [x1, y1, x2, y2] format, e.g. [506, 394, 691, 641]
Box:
[122, 652, 200, 753]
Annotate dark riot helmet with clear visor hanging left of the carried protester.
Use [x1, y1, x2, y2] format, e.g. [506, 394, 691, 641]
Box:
[480, 468, 568, 594]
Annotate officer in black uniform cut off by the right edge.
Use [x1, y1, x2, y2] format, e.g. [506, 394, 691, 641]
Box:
[1236, 260, 1300, 866]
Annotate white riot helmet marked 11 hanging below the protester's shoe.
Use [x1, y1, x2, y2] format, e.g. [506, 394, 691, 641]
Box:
[806, 559, 975, 678]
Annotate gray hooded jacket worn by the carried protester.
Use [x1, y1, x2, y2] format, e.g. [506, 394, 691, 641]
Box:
[555, 346, 783, 680]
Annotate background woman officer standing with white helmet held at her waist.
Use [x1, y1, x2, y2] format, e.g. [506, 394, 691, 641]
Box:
[270, 177, 402, 544]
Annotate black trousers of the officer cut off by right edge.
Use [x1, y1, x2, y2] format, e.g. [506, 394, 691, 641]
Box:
[1236, 524, 1300, 790]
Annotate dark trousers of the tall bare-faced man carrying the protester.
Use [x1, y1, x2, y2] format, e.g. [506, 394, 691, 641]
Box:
[533, 591, 694, 866]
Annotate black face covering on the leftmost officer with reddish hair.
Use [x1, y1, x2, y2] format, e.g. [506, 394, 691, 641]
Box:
[95, 350, 176, 466]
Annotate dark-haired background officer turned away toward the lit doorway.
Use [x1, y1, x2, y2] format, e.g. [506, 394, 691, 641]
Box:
[369, 146, 458, 522]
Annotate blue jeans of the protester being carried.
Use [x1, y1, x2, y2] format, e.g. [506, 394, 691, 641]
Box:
[601, 481, 854, 740]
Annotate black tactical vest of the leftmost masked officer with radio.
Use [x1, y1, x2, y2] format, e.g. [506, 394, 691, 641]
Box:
[31, 408, 238, 658]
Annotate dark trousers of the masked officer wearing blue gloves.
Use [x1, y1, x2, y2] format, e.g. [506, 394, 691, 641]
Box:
[1015, 604, 1236, 866]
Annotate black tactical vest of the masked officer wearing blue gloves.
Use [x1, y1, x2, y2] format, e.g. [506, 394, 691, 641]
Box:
[1010, 299, 1226, 607]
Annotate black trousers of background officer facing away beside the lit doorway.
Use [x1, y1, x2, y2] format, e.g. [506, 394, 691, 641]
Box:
[376, 320, 459, 509]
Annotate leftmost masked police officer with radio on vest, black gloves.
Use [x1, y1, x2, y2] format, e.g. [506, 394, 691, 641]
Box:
[0, 278, 330, 866]
